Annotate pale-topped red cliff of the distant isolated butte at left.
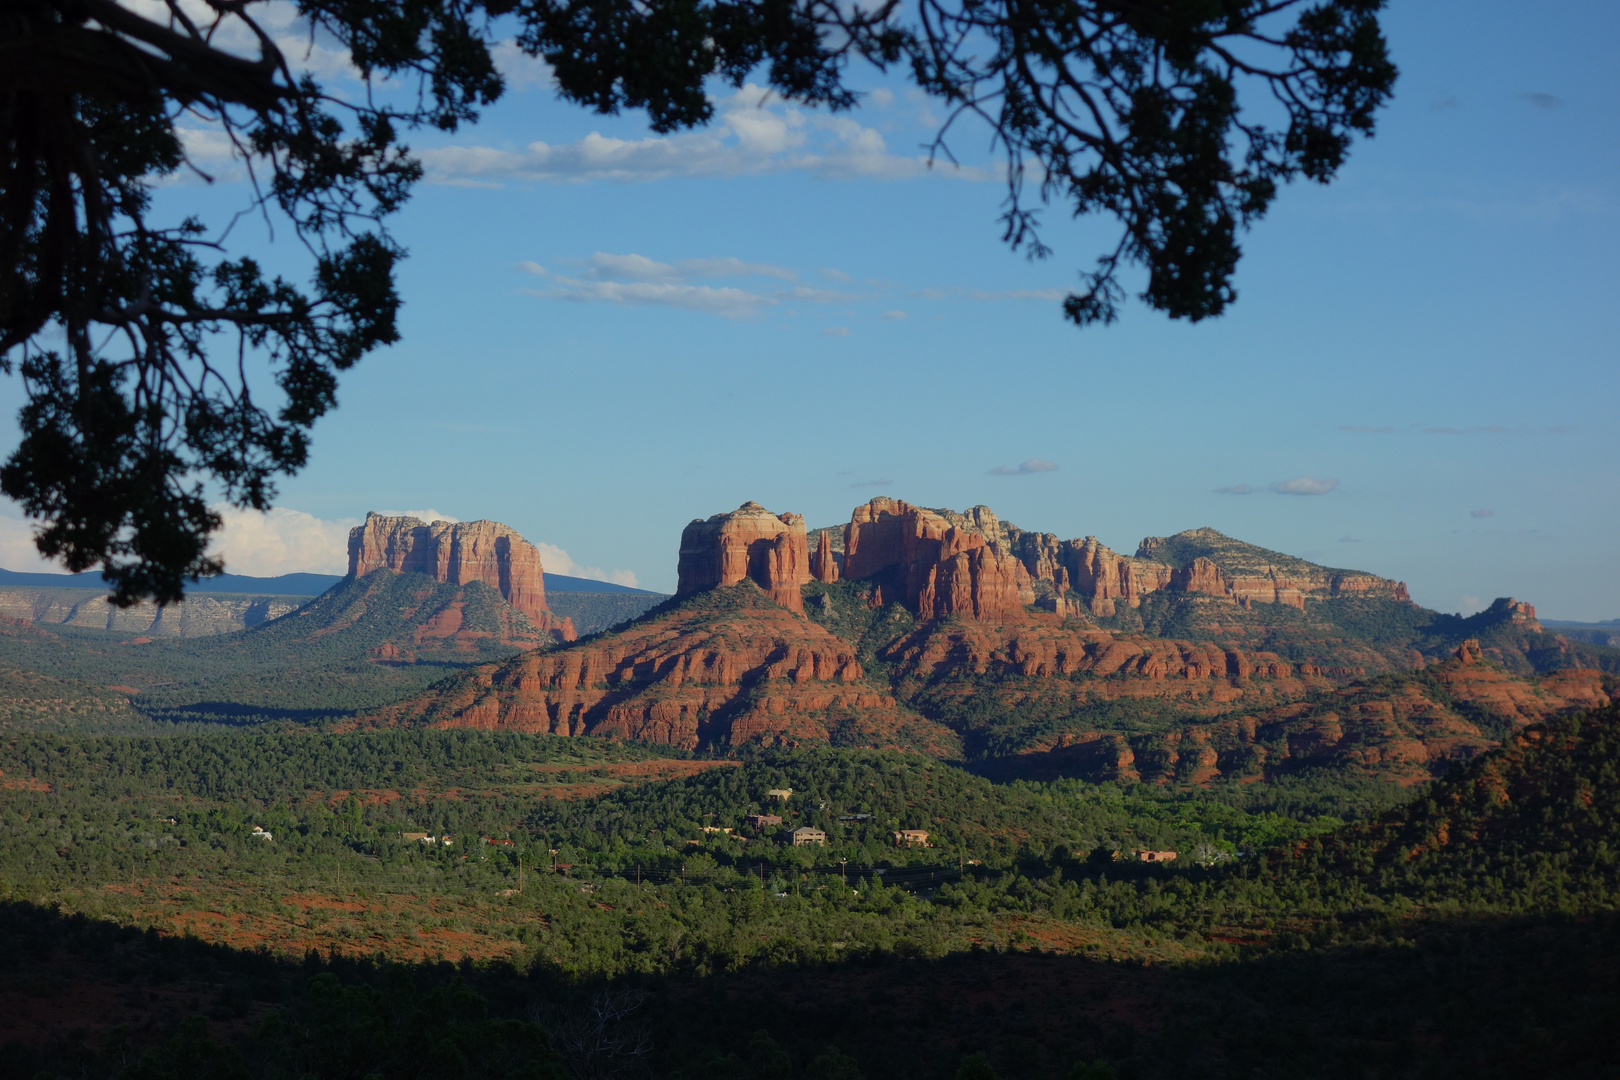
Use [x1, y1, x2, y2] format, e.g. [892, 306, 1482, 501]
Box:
[348, 513, 577, 641]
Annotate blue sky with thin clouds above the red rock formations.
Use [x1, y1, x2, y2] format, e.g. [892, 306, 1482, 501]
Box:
[0, 0, 1620, 620]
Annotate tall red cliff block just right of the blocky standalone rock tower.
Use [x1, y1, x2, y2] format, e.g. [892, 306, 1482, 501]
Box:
[842, 497, 1035, 622]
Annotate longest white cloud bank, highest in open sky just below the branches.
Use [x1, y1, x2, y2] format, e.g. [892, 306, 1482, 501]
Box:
[418, 84, 995, 185]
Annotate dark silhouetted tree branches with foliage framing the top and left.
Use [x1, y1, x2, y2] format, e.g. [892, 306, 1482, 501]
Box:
[0, 0, 1395, 604]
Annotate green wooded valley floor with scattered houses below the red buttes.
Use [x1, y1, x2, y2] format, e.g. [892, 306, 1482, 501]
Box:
[0, 706, 1620, 1080]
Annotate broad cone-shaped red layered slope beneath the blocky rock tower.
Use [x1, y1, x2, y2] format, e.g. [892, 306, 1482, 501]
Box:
[369, 593, 959, 753]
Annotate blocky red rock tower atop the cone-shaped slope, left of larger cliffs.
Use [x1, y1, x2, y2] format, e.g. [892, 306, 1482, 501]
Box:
[676, 502, 810, 612]
